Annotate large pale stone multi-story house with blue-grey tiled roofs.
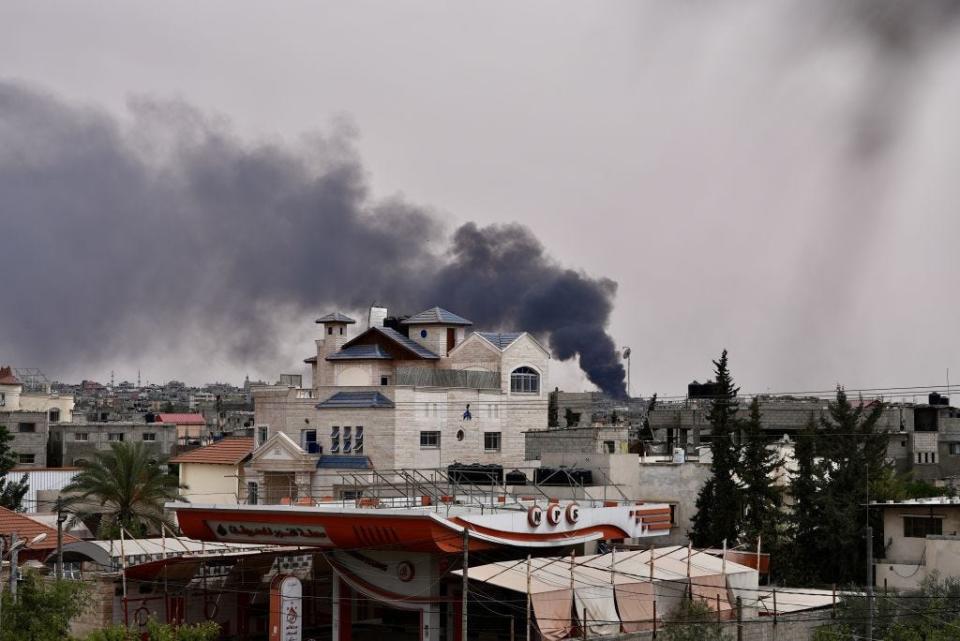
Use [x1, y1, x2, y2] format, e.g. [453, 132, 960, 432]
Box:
[249, 307, 550, 497]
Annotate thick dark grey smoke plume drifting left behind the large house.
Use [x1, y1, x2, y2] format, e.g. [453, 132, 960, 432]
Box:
[0, 82, 625, 396]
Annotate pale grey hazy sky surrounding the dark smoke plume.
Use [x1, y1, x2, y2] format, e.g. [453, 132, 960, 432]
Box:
[0, 0, 960, 394]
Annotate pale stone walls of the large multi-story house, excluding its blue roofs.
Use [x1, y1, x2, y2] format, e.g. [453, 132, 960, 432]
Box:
[253, 308, 550, 492]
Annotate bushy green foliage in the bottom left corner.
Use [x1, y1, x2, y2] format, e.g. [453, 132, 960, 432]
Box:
[0, 570, 87, 641]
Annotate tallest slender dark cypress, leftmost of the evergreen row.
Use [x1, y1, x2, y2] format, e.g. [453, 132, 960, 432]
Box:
[690, 350, 742, 547]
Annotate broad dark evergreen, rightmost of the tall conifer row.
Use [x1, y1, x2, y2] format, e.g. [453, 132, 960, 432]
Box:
[817, 387, 888, 585]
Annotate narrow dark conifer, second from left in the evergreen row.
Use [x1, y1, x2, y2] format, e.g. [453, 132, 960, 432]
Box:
[738, 396, 783, 551]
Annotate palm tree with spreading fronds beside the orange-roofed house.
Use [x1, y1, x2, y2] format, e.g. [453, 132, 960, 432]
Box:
[63, 442, 186, 538]
